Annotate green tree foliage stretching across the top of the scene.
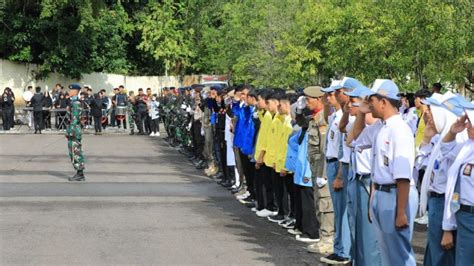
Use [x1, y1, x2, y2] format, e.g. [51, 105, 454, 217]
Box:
[0, 0, 474, 90]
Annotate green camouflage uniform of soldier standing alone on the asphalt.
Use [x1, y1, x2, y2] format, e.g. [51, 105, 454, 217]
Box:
[66, 96, 84, 171]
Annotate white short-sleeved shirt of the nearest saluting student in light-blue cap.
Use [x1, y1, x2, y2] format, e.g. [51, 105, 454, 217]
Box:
[358, 114, 415, 185]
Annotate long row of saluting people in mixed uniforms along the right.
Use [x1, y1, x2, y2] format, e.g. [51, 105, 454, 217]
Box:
[161, 77, 474, 265]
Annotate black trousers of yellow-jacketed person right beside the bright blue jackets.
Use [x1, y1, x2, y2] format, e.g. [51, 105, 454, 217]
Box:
[255, 165, 276, 211]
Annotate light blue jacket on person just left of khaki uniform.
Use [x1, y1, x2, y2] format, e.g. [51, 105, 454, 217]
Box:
[285, 130, 313, 187]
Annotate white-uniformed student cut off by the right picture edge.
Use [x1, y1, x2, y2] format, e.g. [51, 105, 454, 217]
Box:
[441, 96, 474, 266]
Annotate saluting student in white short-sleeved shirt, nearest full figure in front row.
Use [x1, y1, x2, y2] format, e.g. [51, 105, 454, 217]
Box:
[353, 79, 418, 265]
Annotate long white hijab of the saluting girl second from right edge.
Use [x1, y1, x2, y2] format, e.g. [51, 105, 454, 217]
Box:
[420, 105, 467, 215]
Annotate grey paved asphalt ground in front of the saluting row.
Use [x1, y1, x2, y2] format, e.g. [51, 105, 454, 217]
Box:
[0, 131, 425, 265]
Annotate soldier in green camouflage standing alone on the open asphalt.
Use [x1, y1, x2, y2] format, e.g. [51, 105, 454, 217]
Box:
[66, 84, 85, 181]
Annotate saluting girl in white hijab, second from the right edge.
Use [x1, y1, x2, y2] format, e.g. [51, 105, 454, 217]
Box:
[419, 92, 467, 266]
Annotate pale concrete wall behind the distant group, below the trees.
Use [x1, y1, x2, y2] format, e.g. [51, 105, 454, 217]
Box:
[0, 59, 201, 106]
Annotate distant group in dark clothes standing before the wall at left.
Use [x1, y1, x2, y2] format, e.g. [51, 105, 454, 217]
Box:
[0, 84, 159, 136]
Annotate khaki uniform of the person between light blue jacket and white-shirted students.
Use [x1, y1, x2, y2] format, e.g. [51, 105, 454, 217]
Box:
[308, 111, 334, 238]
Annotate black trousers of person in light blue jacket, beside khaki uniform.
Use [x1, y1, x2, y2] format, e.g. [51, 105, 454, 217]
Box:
[294, 184, 320, 238]
